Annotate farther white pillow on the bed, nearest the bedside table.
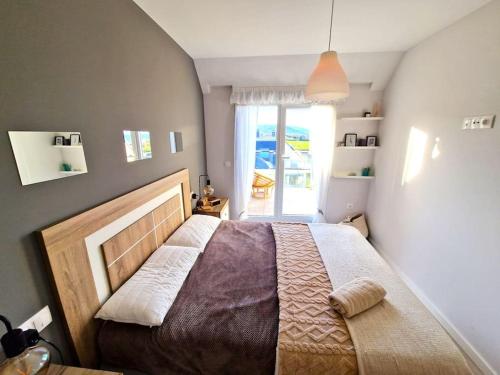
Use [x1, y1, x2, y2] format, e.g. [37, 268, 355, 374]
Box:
[165, 215, 222, 252]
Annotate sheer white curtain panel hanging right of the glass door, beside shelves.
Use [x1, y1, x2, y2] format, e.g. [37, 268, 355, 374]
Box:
[310, 105, 336, 222]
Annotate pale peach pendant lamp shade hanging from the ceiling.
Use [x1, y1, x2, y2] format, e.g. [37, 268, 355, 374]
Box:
[305, 51, 349, 102]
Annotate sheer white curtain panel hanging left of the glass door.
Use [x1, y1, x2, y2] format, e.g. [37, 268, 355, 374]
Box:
[234, 105, 259, 219]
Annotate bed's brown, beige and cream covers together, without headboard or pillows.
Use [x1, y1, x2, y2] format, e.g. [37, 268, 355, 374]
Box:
[98, 221, 470, 375]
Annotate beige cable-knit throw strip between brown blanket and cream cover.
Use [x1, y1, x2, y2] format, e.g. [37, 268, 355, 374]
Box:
[272, 223, 358, 375]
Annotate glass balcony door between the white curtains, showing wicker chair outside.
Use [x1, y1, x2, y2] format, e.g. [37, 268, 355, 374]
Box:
[247, 106, 316, 219]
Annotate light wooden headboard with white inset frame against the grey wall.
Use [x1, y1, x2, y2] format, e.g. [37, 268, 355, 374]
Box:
[40, 169, 191, 367]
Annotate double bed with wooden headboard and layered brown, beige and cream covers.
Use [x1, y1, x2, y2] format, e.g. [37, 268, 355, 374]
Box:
[41, 170, 470, 374]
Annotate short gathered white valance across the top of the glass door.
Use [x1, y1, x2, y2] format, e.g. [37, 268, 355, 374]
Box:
[230, 86, 307, 105]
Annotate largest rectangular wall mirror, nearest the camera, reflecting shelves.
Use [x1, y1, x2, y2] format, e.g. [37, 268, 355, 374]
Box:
[9, 131, 87, 185]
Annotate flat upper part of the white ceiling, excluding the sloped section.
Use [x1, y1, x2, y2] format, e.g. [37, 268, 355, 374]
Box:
[135, 0, 489, 59]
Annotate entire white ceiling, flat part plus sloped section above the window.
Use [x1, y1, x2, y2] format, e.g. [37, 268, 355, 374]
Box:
[134, 0, 490, 93]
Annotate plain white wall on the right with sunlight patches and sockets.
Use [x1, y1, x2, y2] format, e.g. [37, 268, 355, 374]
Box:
[368, 0, 500, 371]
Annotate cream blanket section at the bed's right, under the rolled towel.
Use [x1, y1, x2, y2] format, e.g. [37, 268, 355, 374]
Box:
[309, 224, 472, 375]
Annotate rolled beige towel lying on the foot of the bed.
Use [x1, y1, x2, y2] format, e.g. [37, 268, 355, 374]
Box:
[328, 277, 386, 318]
